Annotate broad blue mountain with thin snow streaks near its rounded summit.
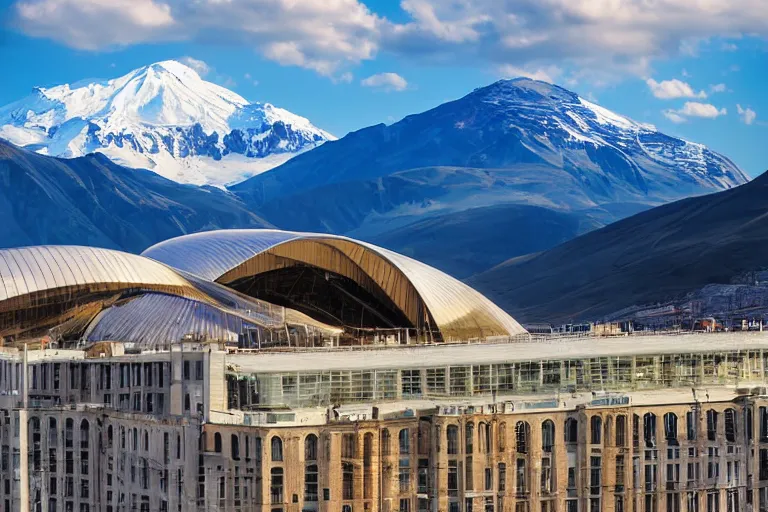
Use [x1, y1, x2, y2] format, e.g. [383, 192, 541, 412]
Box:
[236, 79, 747, 275]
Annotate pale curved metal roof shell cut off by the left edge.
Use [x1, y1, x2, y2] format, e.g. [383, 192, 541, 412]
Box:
[0, 246, 201, 303]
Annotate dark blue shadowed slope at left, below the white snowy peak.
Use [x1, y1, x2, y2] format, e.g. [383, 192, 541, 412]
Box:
[0, 140, 270, 253]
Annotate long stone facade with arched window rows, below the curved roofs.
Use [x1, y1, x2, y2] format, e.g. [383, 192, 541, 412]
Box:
[0, 334, 768, 512]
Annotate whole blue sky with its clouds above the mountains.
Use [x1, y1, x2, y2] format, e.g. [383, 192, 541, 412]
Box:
[0, 0, 768, 176]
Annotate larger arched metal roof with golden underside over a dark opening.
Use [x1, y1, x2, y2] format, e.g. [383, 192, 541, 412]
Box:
[142, 229, 525, 340]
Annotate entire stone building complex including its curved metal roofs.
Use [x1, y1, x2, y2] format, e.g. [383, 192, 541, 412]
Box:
[0, 230, 768, 512]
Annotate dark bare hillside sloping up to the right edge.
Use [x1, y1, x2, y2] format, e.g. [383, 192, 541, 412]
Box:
[469, 174, 768, 322]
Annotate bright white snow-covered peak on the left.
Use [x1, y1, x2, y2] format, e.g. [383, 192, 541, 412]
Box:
[0, 61, 334, 185]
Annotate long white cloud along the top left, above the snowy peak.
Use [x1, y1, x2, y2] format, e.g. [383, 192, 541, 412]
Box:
[12, 0, 380, 76]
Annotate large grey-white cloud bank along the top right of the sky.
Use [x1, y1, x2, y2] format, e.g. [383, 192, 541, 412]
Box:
[382, 0, 768, 81]
